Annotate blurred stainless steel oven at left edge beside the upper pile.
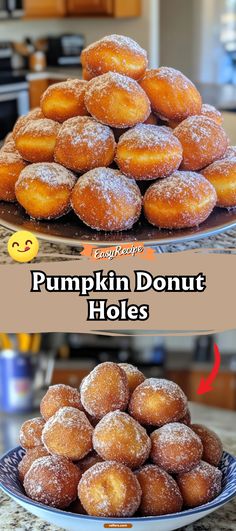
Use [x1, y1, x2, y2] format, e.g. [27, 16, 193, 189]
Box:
[0, 81, 29, 141]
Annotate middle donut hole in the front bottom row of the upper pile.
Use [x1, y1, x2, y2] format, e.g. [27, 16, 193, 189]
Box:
[71, 168, 142, 231]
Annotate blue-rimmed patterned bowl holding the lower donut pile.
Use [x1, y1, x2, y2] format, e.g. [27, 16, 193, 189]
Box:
[0, 447, 236, 531]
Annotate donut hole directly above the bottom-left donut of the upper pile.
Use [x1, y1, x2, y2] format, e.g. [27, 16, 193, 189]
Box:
[15, 118, 60, 162]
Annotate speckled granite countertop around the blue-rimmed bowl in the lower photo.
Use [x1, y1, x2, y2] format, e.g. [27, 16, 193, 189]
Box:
[0, 404, 236, 531]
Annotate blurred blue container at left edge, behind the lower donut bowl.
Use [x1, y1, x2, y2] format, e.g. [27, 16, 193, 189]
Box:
[0, 350, 34, 413]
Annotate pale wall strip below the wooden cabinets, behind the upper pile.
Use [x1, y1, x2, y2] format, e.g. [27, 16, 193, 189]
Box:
[0, 0, 159, 63]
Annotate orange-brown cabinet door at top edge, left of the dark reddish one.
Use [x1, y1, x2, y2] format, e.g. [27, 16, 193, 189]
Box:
[24, 0, 67, 18]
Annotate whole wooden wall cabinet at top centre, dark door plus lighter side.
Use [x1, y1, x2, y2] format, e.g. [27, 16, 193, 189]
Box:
[67, 0, 141, 18]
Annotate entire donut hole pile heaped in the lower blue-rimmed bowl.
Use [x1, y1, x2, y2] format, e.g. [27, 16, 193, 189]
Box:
[18, 362, 223, 518]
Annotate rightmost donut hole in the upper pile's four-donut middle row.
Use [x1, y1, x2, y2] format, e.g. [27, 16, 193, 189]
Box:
[173, 116, 228, 171]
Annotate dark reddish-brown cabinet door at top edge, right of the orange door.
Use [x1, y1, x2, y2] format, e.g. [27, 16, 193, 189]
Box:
[67, 0, 113, 16]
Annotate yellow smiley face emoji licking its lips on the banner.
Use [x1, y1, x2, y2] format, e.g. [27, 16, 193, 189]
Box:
[7, 230, 39, 263]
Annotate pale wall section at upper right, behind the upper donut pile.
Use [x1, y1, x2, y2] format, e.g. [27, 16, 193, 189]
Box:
[160, 0, 228, 83]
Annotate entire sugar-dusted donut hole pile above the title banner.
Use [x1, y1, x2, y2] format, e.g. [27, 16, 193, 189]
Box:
[0, 35, 236, 231]
